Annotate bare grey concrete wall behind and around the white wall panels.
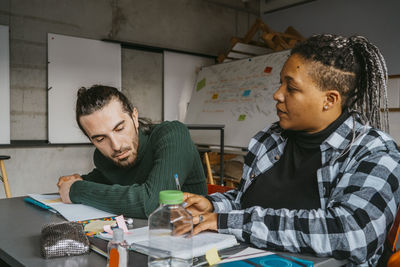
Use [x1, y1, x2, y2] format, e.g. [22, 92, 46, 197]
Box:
[0, 0, 259, 198]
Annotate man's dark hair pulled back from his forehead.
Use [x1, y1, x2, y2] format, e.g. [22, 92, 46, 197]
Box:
[75, 85, 151, 136]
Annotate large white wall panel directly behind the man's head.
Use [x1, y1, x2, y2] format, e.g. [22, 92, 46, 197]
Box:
[48, 34, 121, 144]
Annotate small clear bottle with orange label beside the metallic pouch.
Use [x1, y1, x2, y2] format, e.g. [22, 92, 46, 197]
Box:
[107, 228, 129, 267]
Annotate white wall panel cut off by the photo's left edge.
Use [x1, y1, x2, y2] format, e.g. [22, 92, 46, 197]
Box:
[0, 25, 10, 144]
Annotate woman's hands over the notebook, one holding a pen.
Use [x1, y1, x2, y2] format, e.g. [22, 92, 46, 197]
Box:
[183, 193, 218, 235]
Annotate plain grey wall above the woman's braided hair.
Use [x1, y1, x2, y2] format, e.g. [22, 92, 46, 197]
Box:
[262, 0, 400, 74]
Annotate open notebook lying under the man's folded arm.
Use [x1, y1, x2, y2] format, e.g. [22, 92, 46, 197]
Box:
[28, 194, 116, 222]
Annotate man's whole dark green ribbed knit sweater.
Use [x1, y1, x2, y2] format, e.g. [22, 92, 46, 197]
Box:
[69, 121, 207, 218]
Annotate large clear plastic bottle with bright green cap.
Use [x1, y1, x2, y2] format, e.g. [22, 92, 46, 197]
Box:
[148, 190, 193, 267]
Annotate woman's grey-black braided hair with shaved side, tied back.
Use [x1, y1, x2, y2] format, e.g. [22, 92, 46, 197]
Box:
[291, 34, 389, 132]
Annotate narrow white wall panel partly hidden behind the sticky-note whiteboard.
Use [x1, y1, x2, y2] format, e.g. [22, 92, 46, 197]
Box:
[164, 51, 215, 122]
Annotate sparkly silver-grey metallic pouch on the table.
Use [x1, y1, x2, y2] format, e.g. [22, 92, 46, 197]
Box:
[40, 222, 89, 259]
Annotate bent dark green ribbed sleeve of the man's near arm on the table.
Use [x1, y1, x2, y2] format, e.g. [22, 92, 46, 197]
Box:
[70, 122, 200, 218]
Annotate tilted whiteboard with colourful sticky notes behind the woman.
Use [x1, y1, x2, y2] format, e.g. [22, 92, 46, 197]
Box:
[185, 50, 290, 147]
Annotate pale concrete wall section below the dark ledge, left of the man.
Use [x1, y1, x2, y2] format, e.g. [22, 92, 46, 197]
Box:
[0, 146, 94, 198]
